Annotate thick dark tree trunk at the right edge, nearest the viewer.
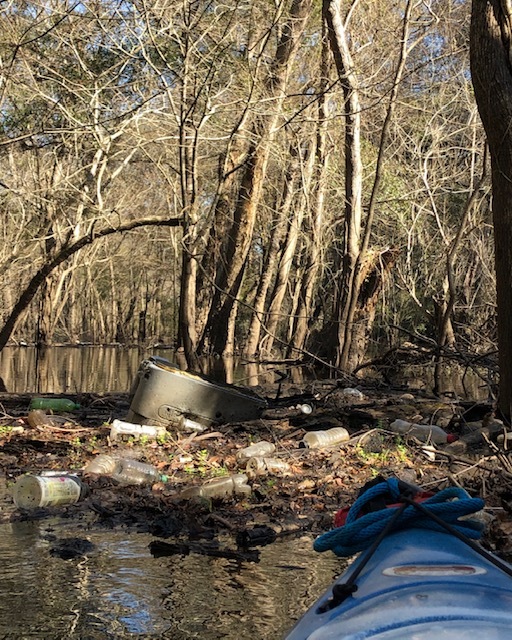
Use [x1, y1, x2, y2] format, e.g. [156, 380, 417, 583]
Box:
[470, 0, 512, 420]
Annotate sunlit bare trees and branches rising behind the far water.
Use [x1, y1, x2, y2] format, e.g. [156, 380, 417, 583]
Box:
[0, 0, 495, 384]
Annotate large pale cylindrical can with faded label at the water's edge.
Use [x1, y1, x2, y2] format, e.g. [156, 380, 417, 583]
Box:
[12, 472, 88, 509]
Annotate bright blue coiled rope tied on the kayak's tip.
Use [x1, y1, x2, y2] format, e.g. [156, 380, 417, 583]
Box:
[313, 478, 484, 557]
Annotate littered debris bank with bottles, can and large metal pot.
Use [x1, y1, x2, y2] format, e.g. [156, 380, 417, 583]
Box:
[0, 358, 512, 564]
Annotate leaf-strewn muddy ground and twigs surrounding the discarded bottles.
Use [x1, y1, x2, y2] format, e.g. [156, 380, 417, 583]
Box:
[0, 380, 512, 560]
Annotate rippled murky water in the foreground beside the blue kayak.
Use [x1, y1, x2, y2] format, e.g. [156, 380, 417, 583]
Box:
[0, 520, 343, 640]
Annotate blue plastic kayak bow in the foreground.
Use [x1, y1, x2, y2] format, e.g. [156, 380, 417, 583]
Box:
[286, 529, 512, 640]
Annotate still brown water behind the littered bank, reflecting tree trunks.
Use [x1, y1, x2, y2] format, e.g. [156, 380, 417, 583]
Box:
[0, 346, 489, 400]
